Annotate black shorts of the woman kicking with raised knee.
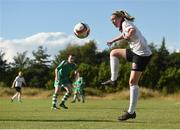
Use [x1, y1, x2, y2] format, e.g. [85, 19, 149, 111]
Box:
[126, 49, 152, 71]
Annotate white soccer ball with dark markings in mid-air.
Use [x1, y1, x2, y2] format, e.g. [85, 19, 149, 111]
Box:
[74, 22, 90, 39]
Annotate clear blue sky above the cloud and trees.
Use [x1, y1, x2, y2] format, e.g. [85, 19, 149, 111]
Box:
[0, 0, 180, 61]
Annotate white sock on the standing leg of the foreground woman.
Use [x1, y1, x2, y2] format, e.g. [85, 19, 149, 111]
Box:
[128, 85, 139, 114]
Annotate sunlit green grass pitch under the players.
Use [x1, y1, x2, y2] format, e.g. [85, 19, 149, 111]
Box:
[0, 99, 180, 129]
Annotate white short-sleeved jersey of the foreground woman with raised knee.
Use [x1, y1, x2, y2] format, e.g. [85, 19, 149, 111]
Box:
[122, 20, 152, 56]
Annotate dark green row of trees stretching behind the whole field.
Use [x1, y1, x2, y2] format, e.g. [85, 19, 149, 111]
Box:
[0, 38, 180, 94]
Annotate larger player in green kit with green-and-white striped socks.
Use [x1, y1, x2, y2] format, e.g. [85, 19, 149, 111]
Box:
[52, 54, 77, 109]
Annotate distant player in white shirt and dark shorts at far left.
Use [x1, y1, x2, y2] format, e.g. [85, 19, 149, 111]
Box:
[11, 71, 26, 102]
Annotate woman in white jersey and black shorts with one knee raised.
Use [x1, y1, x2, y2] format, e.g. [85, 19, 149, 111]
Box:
[102, 11, 152, 121]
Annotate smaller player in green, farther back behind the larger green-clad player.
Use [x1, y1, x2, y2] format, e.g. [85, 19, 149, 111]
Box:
[71, 71, 85, 103]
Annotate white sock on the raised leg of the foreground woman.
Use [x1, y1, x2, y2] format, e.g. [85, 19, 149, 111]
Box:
[110, 56, 119, 81]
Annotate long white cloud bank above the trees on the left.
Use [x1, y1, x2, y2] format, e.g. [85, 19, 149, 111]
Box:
[0, 32, 89, 62]
